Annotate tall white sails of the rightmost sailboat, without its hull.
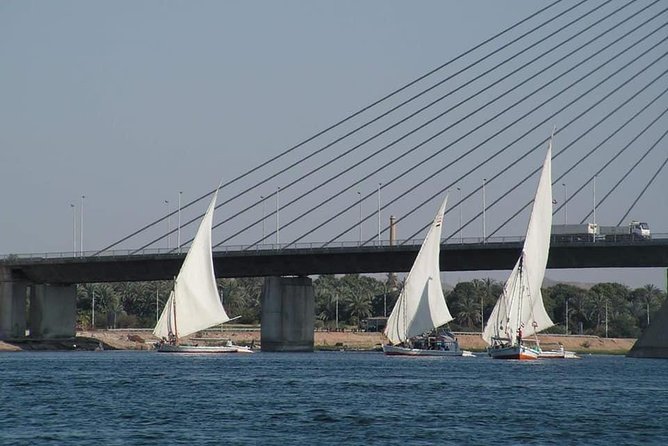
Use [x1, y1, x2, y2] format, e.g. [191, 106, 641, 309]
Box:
[483, 139, 554, 344]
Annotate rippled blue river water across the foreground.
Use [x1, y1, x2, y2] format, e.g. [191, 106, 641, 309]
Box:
[0, 351, 668, 445]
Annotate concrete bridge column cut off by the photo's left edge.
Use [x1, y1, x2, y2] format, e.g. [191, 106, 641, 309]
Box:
[0, 268, 28, 339]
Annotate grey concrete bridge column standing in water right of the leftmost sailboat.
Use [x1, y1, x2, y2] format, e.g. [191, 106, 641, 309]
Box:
[260, 277, 315, 352]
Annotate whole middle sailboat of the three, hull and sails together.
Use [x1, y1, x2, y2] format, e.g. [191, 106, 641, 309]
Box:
[383, 196, 473, 356]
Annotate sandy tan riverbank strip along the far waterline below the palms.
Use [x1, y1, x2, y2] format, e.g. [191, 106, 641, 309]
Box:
[0, 326, 636, 355]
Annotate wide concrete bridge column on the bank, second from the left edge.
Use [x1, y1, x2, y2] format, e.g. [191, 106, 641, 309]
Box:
[30, 285, 77, 338]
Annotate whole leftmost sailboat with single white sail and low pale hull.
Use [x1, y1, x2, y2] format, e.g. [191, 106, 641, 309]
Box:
[153, 189, 251, 353]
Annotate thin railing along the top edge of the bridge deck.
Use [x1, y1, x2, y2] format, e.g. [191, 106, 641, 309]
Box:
[0, 234, 668, 260]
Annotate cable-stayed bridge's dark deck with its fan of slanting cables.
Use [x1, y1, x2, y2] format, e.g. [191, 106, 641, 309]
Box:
[0, 0, 668, 344]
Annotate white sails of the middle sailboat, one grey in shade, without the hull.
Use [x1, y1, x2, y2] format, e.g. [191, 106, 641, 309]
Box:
[385, 196, 452, 344]
